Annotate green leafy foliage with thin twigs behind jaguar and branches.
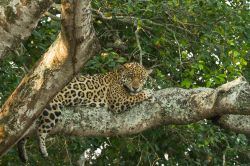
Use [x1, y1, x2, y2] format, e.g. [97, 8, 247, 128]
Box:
[0, 0, 250, 165]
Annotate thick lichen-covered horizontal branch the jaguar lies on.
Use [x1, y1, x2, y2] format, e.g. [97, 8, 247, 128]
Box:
[23, 78, 250, 136]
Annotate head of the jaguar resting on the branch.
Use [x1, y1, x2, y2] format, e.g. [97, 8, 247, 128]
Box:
[120, 62, 152, 94]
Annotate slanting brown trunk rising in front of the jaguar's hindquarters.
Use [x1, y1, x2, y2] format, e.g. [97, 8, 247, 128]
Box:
[0, 0, 99, 156]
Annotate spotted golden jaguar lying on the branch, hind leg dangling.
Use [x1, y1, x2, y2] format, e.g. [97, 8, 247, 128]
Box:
[19, 62, 152, 161]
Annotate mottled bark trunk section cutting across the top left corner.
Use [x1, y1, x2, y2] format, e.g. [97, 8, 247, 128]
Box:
[0, 0, 53, 59]
